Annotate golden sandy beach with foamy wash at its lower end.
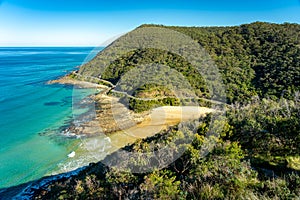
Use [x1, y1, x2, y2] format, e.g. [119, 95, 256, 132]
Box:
[53, 102, 214, 174]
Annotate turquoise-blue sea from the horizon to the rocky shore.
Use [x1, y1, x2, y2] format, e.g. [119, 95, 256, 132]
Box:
[0, 47, 99, 188]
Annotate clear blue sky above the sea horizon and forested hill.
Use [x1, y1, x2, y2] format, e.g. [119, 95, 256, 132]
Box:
[0, 0, 300, 46]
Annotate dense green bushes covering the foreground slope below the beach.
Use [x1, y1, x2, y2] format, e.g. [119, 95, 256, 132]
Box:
[31, 96, 300, 199]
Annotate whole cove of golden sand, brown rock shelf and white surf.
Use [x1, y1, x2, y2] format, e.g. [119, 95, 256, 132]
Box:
[48, 76, 214, 175]
